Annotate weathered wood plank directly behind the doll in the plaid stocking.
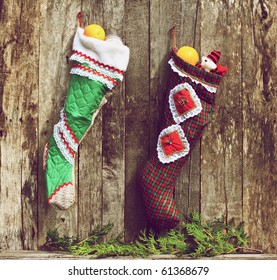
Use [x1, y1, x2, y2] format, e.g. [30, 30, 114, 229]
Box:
[199, 1, 227, 219]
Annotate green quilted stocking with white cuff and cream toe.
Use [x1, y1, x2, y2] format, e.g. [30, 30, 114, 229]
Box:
[44, 27, 129, 209]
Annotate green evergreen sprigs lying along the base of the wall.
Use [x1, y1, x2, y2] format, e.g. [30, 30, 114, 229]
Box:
[42, 212, 248, 258]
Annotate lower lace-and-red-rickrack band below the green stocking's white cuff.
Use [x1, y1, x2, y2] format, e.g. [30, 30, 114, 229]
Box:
[70, 64, 117, 89]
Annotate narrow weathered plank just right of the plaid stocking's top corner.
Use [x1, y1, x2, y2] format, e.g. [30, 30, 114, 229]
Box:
[219, 1, 243, 222]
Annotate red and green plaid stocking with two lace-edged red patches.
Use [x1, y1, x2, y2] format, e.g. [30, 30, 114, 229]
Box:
[140, 52, 222, 230]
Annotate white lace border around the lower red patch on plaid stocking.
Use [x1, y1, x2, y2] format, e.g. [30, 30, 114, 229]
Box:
[157, 124, 190, 163]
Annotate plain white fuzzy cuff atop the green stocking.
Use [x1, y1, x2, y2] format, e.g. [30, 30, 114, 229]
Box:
[73, 27, 130, 71]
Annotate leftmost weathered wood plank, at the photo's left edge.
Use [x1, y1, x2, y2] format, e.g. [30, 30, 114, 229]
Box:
[0, 2, 22, 252]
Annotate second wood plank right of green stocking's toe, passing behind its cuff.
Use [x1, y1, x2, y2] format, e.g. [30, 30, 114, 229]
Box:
[102, 0, 125, 241]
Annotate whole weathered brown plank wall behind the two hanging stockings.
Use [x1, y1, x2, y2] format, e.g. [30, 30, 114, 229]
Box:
[0, 0, 277, 253]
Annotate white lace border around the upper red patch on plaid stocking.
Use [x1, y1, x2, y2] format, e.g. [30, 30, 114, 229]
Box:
[169, 83, 202, 124]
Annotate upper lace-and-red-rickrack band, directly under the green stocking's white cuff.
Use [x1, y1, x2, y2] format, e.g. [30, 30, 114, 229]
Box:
[70, 52, 124, 81]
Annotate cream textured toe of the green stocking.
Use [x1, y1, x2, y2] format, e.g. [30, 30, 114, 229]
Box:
[49, 184, 75, 210]
